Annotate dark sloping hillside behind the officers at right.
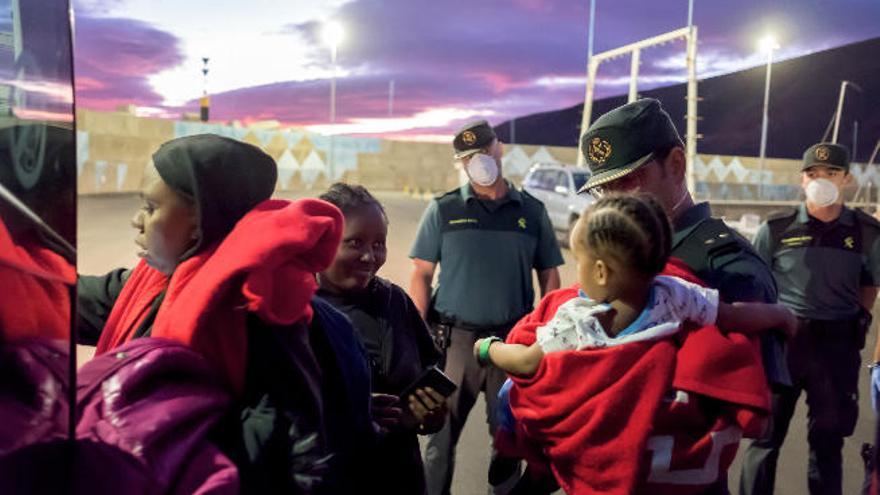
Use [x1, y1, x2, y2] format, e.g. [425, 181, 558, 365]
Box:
[495, 38, 880, 161]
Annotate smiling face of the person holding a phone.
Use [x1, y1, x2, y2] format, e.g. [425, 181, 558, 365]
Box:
[321, 205, 388, 292]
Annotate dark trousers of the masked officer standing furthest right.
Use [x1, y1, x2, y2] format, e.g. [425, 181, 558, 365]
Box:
[740, 320, 864, 495]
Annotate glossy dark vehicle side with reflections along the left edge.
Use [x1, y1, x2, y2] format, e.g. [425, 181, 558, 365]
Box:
[0, 0, 76, 493]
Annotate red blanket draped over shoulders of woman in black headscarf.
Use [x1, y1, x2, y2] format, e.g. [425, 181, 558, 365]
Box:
[97, 199, 343, 390]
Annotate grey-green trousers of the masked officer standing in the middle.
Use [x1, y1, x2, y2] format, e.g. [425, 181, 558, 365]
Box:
[424, 328, 507, 495]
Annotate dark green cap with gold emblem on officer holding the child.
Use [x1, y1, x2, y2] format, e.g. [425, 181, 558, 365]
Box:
[578, 98, 684, 192]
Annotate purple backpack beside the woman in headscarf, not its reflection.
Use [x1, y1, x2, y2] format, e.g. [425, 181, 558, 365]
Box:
[74, 338, 239, 494]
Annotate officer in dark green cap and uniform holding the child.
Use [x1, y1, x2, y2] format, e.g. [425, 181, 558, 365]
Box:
[581, 98, 790, 493]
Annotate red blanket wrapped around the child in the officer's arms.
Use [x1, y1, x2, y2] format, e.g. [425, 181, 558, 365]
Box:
[508, 260, 769, 494]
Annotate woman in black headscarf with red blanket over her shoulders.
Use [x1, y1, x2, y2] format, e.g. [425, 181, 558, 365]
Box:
[78, 134, 350, 493]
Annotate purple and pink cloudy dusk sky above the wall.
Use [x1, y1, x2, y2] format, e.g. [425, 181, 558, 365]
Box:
[73, 0, 880, 140]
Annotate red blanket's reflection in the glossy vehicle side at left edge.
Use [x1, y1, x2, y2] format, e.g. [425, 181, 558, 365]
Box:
[0, 219, 76, 341]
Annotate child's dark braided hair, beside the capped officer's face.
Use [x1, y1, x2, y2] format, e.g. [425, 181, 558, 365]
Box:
[577, 193, 672, 277]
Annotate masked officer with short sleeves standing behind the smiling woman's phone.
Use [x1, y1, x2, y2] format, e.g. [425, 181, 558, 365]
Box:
[410, 120, 563, 494]
